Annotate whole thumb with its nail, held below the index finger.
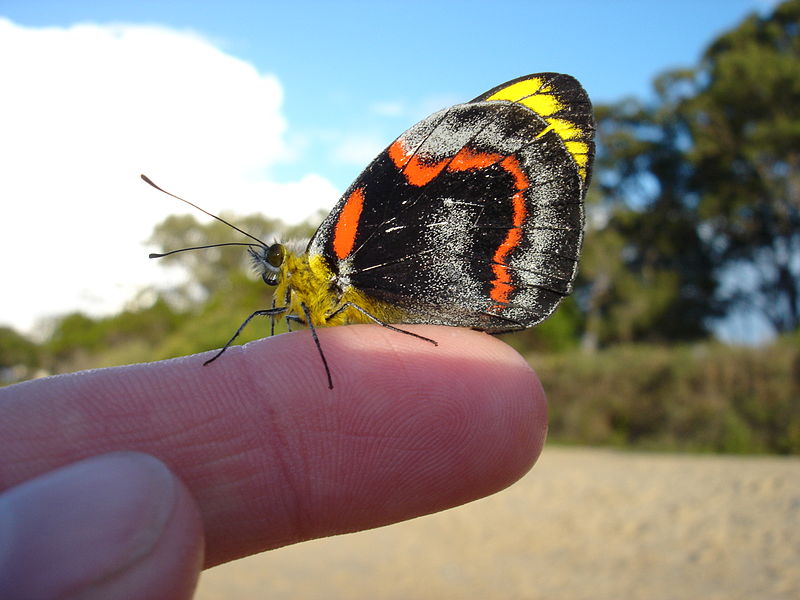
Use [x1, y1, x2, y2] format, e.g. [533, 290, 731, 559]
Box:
[0, 452, 203, 599]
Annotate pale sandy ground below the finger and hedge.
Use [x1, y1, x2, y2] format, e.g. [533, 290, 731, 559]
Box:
[197, 446, 800, 600]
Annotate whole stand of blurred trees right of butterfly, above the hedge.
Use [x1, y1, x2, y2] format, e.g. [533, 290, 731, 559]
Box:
[577, 0, 800, 345]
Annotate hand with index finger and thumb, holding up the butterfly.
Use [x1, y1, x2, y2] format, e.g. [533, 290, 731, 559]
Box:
[0, 325, 546, 599]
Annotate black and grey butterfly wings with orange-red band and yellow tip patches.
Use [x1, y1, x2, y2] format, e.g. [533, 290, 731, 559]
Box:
[308, 73, 594, 332]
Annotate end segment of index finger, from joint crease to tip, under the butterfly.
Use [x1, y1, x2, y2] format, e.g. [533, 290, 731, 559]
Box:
[228, 326, 547, 537]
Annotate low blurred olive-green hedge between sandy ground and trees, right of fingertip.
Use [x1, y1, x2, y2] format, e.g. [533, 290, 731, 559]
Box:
[531, 336, 800, 454]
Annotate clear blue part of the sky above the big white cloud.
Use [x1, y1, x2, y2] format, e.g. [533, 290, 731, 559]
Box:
[0, 0, 774, 189]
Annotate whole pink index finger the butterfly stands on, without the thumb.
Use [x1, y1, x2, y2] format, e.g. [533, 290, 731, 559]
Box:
[0, 325, 546, 566]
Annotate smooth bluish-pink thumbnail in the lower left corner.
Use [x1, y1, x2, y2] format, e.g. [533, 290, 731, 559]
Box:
[0, 452, 176, 598]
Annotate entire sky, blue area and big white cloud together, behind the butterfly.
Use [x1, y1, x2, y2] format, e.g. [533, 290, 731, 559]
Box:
[0, 0, 775, 333]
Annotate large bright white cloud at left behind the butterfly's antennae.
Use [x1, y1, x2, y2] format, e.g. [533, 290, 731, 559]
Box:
[0, 19, 338, 330]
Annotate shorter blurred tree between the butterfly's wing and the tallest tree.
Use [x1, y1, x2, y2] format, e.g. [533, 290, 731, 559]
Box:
[577, 92, 722, 347]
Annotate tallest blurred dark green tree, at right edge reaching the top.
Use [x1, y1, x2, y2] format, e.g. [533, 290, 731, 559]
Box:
[680, 0, 800, 332]
